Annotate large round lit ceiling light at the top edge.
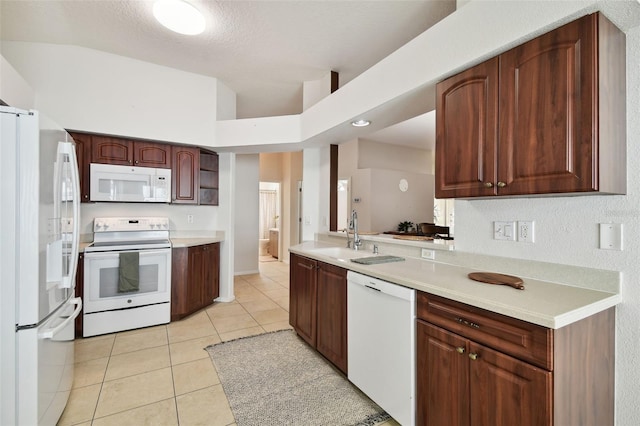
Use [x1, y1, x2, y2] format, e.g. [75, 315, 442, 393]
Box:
[153, 0, 205, 35]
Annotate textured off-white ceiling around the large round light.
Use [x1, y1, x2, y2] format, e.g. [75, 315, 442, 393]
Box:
[0, 0, 455, 146]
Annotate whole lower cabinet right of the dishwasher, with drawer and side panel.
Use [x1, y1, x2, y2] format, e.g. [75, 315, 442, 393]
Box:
[416, 292, 615, 426]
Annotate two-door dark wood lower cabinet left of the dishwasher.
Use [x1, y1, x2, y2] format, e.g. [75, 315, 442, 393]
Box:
[289, 253, 347, 374]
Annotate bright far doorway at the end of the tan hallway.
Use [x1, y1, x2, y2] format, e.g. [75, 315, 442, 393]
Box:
[258, 182, 280, 262]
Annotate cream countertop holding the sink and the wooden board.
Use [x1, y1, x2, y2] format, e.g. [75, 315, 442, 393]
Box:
[289, 241, 622, 329]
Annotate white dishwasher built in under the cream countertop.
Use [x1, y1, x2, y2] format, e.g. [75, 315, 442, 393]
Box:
[347, 271, 416, 426]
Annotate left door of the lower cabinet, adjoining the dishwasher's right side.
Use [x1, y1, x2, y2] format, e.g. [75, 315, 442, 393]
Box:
[416, 321, 470, 426]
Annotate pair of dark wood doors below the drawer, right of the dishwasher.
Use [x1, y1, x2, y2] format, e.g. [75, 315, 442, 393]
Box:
[417, 321, 552, 426]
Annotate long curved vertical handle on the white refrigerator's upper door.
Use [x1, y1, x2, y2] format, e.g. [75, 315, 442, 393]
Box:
[59, 142, 80, 288]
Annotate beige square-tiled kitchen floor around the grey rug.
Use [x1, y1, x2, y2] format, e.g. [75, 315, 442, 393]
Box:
[58, 262, 398, 426]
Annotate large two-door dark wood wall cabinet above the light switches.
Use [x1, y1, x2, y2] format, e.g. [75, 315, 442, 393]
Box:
[435, 13, 626, 198]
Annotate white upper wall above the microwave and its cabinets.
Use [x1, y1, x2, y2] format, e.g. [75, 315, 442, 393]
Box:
[2, 41, 217, 147]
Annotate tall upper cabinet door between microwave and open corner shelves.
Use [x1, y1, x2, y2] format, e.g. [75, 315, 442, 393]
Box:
[171, 146, 200, 204]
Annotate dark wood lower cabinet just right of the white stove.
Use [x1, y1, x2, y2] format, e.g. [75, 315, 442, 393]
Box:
[171, 243, 220, 321]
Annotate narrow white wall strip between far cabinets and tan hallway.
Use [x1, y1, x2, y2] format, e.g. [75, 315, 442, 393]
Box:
[234, 154, 260, 275]
